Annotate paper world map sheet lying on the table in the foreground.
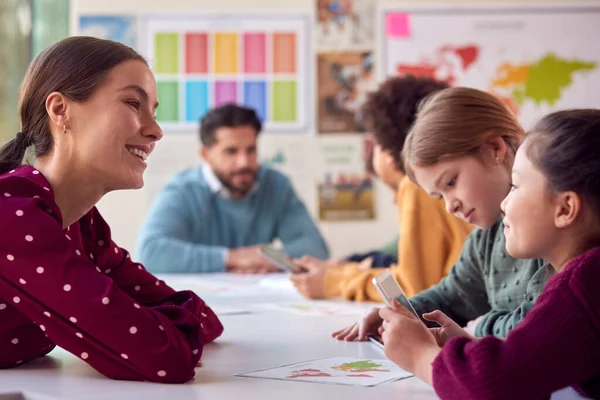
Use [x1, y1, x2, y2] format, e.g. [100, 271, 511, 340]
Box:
[237, 357, 413, 386]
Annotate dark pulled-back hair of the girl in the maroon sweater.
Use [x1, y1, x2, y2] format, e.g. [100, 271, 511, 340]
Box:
[525, 109, 600, 218]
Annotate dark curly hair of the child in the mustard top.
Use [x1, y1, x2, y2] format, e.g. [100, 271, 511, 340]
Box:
[363, 75, 448, 172]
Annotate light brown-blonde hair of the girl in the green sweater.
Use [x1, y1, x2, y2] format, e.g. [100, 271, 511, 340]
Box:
[402, 87, 525, 181]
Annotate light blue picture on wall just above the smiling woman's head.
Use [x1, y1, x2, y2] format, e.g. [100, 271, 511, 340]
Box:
[79, 15, 138, 49]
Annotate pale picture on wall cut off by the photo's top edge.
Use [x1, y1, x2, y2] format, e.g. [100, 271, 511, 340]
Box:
[315, 0, 375, 50]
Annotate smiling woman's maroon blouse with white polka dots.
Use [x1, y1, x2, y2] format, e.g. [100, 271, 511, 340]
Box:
[0, 170, 225, 382]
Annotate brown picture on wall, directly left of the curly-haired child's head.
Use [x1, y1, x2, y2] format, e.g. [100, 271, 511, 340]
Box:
[317, 51, 377, 133]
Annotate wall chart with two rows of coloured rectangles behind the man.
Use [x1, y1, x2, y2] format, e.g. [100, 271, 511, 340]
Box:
[141, 14, 310, 132]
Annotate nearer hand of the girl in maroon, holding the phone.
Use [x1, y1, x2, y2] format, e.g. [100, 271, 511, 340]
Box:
[379, 300, 440, 382]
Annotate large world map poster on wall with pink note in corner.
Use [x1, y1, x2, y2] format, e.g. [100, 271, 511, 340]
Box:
[380, 4, 600, 128]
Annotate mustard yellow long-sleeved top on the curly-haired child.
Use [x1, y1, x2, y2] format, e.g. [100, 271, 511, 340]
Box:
[324, 176, 473, 301]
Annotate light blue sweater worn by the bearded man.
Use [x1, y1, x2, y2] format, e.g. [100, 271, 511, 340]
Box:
[137, 166, 329, 273]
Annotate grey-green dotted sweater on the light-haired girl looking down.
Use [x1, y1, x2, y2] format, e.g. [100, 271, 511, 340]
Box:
[411, 221, 554, 338]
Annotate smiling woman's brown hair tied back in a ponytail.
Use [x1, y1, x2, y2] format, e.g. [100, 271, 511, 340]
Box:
[0, 36, 146, 174]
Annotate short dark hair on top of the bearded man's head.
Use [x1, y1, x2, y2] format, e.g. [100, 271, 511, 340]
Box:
[200, 104, 262, 147]
